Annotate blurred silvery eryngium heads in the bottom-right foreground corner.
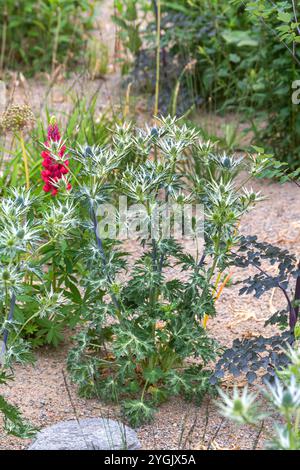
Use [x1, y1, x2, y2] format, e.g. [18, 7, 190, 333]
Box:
[219, 348, 300, 450]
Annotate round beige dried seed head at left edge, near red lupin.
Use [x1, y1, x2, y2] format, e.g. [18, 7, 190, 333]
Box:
[0, 104, 35, 132]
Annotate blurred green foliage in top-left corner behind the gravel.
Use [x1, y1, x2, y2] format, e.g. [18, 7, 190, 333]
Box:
[0, 0, 93, 74]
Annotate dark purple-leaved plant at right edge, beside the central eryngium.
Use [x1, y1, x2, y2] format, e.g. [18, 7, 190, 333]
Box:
[211, 158, 300, 383]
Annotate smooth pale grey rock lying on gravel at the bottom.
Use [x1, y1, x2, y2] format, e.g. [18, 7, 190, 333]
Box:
[28, 418, 141, 450]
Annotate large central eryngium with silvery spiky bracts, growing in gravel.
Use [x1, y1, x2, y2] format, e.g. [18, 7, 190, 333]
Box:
[68, 118, 268, 425]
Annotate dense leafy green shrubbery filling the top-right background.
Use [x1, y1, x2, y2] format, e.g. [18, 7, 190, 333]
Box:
[120, 0, 300, 169]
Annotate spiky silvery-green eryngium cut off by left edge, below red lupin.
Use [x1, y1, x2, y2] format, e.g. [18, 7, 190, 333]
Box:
[0, 189, 76, 437]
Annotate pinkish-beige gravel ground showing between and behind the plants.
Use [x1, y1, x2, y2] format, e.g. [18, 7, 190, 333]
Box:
[0, 0, 300, 449]
